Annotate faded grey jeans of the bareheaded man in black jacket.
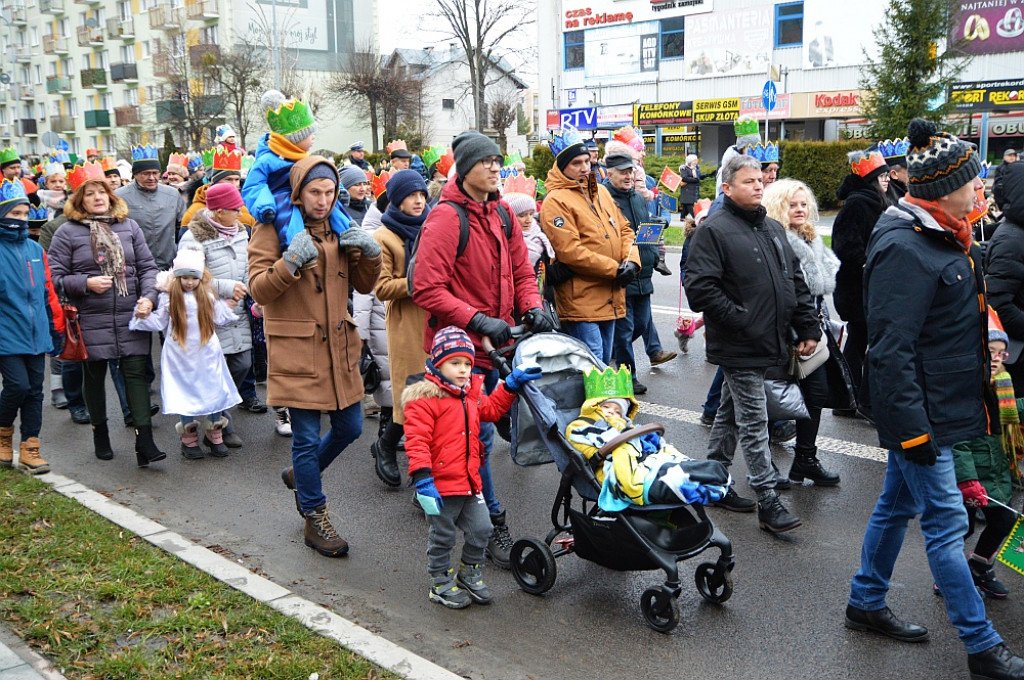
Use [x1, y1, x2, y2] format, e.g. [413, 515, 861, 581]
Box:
[708, 368, 770, 491]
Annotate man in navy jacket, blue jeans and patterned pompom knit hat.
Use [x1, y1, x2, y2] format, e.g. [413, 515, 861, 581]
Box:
[846, 118, 1024, 680]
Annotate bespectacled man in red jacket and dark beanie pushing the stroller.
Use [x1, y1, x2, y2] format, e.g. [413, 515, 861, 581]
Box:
[413, 130, 554, 568]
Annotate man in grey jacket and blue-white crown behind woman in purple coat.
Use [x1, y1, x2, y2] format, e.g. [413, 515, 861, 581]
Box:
[115, 144, 185, 270]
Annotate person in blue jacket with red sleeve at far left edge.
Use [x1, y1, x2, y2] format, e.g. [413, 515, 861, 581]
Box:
[0, 178, 65, 474]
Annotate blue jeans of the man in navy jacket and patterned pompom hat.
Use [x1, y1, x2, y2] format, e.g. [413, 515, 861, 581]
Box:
[850, 447, 1002, 654]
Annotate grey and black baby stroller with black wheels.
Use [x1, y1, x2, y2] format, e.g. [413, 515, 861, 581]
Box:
[490, 333, 733, 633]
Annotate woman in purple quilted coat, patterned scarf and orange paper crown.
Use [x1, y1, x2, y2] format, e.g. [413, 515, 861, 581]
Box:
[48, 163, 162, 467]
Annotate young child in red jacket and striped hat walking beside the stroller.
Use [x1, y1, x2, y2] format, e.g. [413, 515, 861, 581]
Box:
[401, 326, 541, 609]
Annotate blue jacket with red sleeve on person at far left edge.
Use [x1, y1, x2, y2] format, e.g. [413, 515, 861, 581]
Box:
[0, 226, 65, 356]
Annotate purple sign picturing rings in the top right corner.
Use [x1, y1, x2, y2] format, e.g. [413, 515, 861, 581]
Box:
[949, 0, 1024, 54]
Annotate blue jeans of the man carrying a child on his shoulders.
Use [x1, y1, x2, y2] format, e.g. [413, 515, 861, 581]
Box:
[289, 401, 362, 514]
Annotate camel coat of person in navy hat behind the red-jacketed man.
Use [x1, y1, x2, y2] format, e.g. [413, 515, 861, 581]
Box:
[374, 226, 427, 425]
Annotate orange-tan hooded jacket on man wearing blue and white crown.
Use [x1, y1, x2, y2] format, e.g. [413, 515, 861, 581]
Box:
[541, 165, 640, 322]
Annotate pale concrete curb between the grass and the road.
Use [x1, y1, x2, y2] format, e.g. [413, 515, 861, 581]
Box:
[37, 473, 463, 680]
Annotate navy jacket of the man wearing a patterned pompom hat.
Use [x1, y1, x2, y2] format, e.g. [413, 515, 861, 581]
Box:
[864, 200, 998, 451]
